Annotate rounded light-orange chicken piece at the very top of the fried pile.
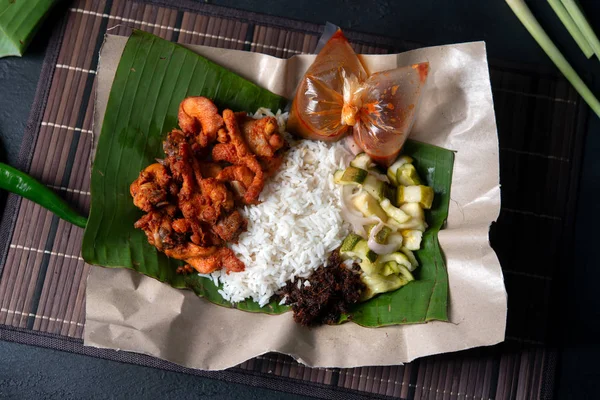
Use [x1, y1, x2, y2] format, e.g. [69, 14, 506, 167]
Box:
[178, 96, 223, 147]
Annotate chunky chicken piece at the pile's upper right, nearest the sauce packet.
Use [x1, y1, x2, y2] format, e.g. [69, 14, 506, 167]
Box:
[236, 113, 285, 158]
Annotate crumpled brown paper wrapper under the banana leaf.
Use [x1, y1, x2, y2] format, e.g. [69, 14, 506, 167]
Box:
[84, 35, 506, 370]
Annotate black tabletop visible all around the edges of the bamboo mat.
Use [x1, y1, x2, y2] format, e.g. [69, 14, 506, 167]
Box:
[0, 0, 600, 399]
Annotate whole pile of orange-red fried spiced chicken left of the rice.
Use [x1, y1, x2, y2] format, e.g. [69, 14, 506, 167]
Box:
[130, 97, 285, 274]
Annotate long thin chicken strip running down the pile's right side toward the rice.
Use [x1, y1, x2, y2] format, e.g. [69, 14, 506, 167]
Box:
[212, 110, 265, 204]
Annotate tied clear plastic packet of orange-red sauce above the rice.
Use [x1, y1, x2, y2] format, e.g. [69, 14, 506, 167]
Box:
[288, 29, 429, 166]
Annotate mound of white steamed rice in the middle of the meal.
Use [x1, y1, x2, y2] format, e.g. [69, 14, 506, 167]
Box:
[212, 109, 351, 307]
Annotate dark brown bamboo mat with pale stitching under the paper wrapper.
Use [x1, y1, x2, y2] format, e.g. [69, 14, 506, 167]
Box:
[0, 0, 586, 400]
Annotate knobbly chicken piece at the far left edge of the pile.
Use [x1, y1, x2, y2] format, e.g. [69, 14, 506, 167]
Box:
[129, 163, 171, 212]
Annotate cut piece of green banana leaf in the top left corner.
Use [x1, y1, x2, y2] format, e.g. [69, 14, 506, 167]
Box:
[0, 0, 54, 57]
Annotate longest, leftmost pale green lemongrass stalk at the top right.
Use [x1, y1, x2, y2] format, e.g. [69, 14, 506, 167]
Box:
[506, 0, 600, 117]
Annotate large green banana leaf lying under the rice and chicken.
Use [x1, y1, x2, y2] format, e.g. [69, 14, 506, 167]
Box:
[82, 30, 453, 326]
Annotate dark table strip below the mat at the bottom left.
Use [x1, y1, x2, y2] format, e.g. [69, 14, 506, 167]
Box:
[0, 342, 305, 400]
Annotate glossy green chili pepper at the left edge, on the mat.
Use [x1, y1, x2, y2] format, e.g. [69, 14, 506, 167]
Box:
[0, 163, 87, 228]
